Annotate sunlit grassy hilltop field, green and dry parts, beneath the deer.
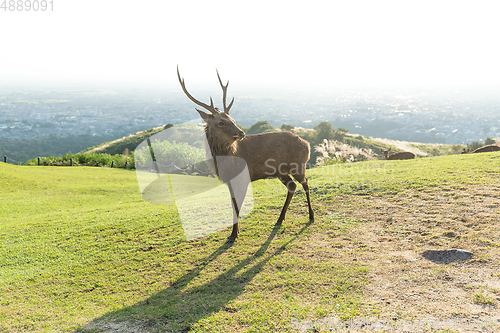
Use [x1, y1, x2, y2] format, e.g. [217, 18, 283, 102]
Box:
[0, 153, 500, 332]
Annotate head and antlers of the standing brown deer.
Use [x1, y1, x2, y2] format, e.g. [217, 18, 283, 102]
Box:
[177, 66, 245, 147]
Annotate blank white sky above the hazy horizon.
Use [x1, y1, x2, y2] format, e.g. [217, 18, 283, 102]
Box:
[0, 0, 500, 88]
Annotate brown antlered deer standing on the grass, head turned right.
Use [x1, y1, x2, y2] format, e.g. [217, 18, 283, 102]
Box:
[177, 66, 314, 243]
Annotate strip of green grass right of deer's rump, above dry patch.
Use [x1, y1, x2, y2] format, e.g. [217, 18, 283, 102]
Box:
[308, 153, 500, 197]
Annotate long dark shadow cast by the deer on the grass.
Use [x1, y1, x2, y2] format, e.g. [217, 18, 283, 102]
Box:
[76, 222, 312, 332]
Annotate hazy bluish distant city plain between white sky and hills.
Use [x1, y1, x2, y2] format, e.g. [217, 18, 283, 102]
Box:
[0, 86, 500, 144]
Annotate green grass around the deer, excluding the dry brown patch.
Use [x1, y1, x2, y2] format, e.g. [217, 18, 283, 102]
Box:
[0, 153, 500, 332]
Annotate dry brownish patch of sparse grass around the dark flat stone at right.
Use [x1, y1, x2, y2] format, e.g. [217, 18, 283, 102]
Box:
[326, 184, 500, 331]
